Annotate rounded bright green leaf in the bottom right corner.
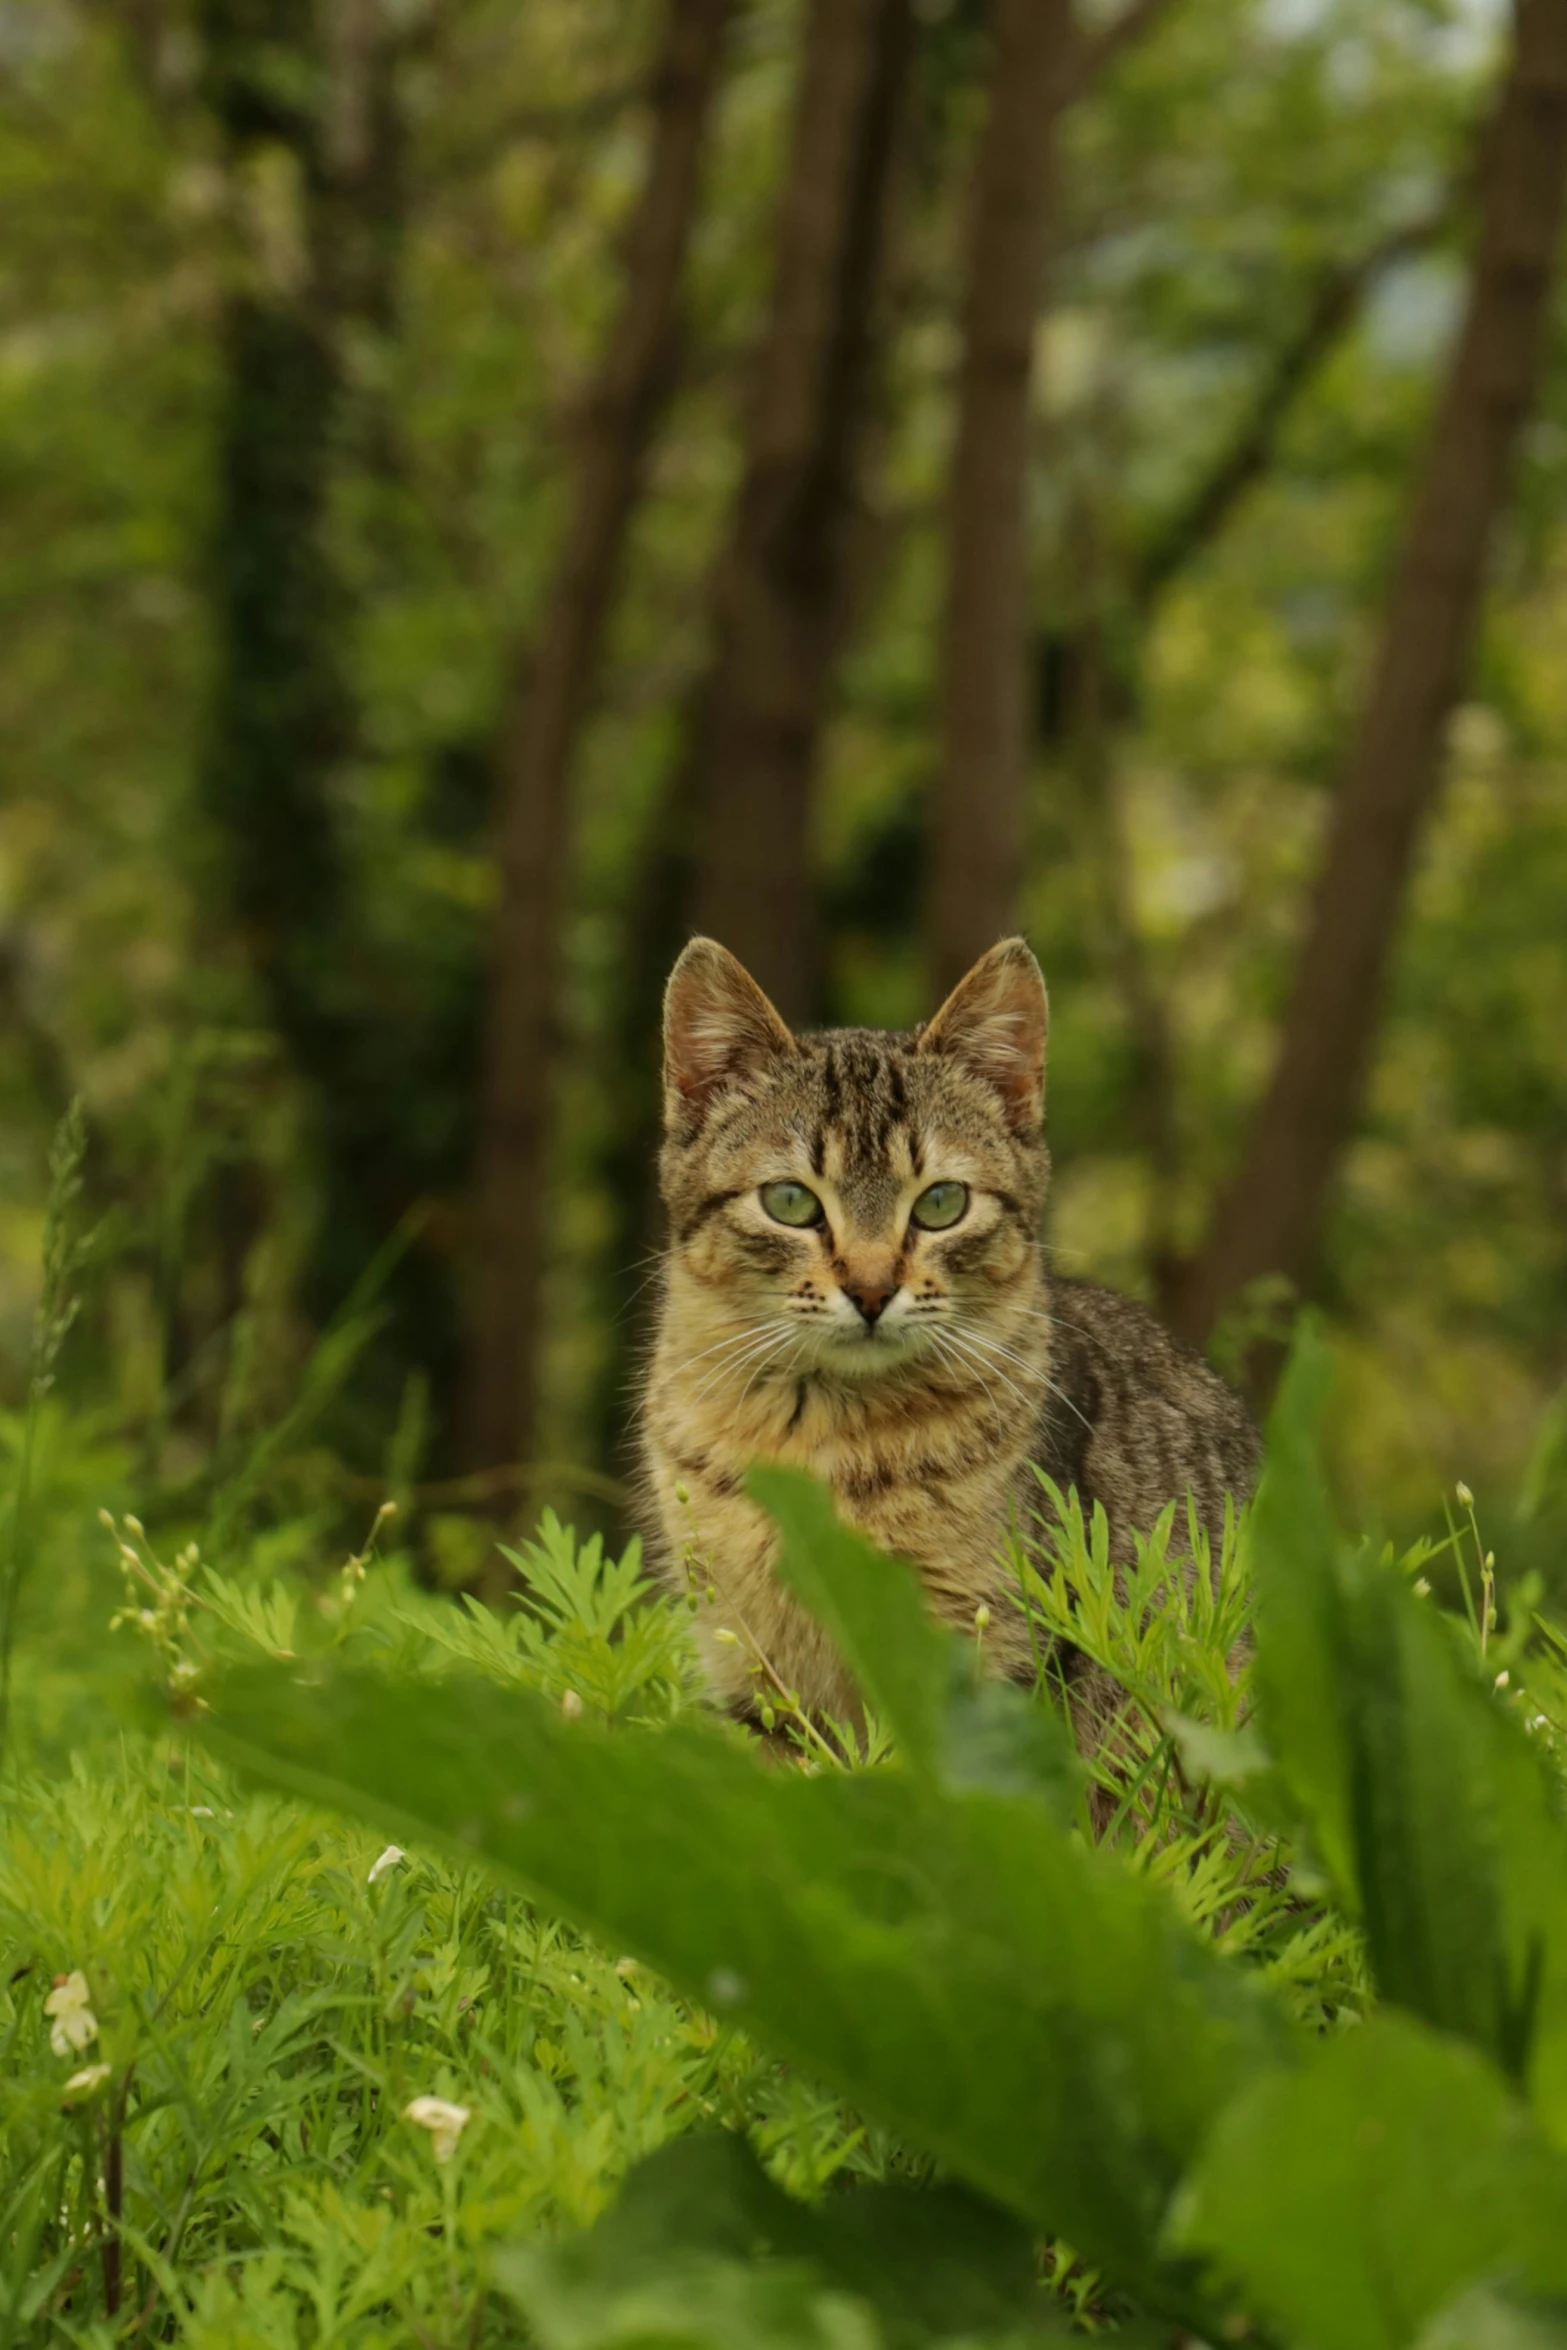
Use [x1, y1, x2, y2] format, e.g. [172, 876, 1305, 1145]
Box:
[1172, 2014, 1567, 2350]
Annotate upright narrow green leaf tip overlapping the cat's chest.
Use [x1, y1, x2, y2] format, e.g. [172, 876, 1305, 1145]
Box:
[747, 1466, 1081, 1821]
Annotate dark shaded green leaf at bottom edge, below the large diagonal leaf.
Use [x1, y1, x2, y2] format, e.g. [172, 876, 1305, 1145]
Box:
[496, 2134, 1064, 2350]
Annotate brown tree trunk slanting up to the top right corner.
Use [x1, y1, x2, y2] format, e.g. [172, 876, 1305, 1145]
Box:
[1172, 0, 1567, 1342]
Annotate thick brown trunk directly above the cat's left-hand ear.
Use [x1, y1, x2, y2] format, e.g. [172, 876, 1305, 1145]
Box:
[695, 0, 914, 1020]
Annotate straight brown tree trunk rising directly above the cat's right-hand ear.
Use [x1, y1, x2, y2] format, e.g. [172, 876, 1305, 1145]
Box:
[930, 0, 1076, 996]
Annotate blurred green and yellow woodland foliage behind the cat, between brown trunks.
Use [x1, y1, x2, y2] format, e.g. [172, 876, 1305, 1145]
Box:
[0, 0, 1567, 1579]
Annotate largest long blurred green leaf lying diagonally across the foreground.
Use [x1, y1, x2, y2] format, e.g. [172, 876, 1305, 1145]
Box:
[200, 1666, 1299, 2308]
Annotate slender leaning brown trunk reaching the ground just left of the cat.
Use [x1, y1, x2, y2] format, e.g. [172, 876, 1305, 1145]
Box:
[468, 0, 733, 1469]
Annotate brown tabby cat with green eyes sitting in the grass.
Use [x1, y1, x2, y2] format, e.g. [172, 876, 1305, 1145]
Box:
[641, 938, 1257, 1739]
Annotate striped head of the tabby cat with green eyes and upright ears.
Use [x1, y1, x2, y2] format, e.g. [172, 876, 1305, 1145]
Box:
[660, 938, 1050, 1377]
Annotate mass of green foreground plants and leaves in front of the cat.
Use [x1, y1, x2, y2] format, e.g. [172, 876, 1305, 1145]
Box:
[0, 1316, 1567, 2350]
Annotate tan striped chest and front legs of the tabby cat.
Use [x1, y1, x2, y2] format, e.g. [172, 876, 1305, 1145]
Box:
[644, 1358, 1036, 1718]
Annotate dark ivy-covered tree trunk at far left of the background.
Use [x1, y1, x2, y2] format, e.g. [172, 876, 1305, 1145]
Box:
[195, 0, 472, 1428]
